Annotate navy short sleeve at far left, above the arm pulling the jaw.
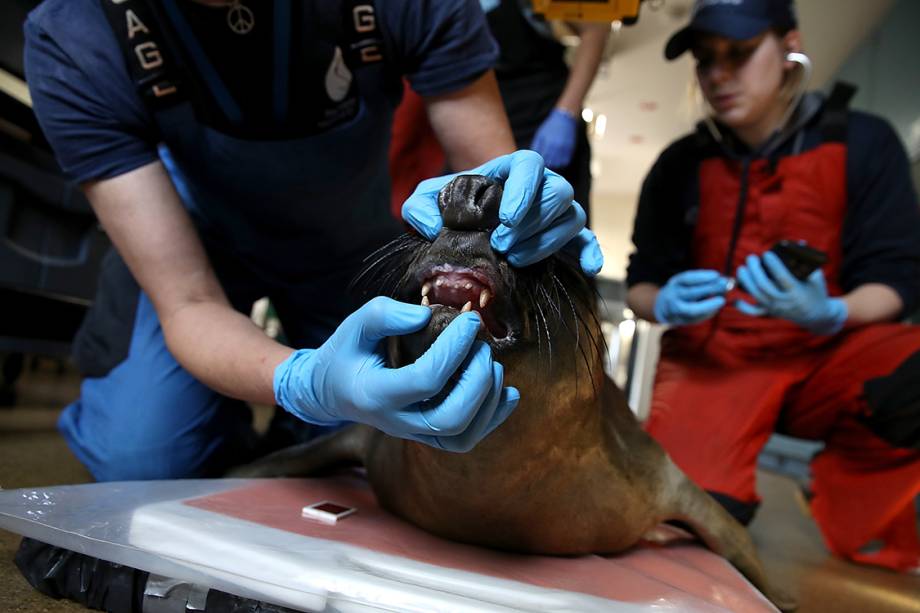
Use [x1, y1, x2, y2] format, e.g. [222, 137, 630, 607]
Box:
[24, 0, 157, 183]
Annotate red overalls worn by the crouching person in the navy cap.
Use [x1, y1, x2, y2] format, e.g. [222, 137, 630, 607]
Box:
[646, 142, 920, 570]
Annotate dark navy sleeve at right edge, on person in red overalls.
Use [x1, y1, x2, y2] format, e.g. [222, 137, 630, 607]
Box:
[841, 112, 920, 316]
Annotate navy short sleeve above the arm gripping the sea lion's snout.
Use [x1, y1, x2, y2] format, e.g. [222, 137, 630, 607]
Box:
[381, 0, 498, 96]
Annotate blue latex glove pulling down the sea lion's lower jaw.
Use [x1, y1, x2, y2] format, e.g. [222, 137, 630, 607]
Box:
[274, 297, 520, 451]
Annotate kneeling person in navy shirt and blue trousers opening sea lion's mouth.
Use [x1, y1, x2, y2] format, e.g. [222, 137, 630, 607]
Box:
[25, 0, 602, 480]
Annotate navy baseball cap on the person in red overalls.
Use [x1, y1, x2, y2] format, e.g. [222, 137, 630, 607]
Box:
[664, 0, 796, 60]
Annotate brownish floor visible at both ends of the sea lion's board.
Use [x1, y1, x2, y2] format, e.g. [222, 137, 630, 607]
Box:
[0, 365, 920, 613]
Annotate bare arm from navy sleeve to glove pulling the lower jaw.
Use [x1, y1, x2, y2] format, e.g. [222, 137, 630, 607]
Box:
[84, 162, 291, 403]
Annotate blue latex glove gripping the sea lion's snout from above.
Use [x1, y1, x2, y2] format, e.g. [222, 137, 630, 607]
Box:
[402, 150, 604, 276]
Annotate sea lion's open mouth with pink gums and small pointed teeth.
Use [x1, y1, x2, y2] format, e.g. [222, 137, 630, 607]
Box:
[421, 264, 511, 342]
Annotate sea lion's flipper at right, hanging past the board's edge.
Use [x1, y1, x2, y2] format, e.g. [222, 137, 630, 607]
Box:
[667, 458, 798, 611]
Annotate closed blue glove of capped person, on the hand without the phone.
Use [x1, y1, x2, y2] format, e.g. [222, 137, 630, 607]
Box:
[653, 270, 728, 326]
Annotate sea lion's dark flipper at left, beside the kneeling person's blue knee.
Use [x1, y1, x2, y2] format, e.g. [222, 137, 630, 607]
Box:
[226, 424, 375, 478]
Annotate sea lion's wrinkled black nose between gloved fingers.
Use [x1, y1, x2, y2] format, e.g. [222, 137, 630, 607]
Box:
[438, 175, 502, 232]
